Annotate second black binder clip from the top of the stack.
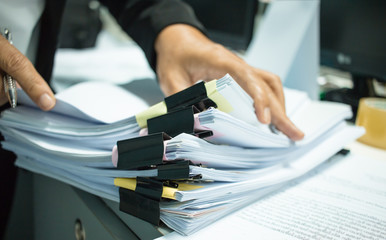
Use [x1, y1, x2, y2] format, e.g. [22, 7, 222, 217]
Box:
[147, 106, 213, 138]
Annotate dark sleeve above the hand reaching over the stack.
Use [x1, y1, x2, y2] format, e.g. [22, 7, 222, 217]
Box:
[100, 0, 205, 71]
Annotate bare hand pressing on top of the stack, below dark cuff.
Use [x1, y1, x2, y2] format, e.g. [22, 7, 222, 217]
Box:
[155, 24, 304, 141]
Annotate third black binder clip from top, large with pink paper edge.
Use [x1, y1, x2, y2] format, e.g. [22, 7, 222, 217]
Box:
[117, 132, 171, 170]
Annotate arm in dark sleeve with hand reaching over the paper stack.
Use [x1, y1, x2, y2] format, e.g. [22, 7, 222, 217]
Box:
[101, 0, 304, 140]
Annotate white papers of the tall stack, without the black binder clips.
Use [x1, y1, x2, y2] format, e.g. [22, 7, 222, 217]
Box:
[0, 75, 363, 235]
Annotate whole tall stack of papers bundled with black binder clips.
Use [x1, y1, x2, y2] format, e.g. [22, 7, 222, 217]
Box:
[0, 75, 363, 235]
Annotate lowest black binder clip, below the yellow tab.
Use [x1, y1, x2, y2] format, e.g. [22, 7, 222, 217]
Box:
[119, 177, 163, 225]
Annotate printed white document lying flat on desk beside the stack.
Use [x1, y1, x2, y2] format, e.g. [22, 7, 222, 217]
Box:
[159, 155, 386, 240]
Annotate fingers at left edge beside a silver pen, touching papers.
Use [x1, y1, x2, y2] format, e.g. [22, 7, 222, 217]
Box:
[0, 35, 56, 111]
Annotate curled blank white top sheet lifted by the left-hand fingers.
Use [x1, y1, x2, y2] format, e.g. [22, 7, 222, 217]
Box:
[13, 82, 149, 124]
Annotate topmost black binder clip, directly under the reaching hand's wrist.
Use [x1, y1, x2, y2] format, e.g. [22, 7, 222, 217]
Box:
[165, 82, 217, 112]
